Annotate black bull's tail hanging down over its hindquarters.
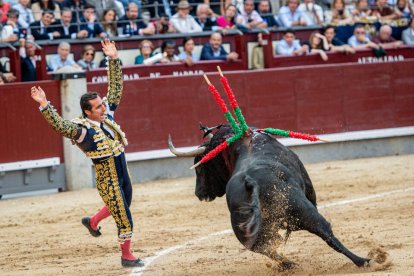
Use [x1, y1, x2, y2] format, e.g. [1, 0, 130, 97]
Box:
[238, 179, 262, 249]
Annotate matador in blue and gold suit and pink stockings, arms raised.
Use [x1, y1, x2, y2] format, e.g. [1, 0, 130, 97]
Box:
[31, 39, 144, 267]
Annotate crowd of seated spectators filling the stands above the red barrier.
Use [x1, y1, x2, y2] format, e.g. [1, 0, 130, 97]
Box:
[0, 0, 414, 82]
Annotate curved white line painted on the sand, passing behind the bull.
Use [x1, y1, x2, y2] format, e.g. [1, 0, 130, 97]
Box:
[130, 187, 414, 276]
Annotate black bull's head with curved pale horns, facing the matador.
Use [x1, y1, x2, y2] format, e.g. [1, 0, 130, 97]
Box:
[168, 125, 231, 201]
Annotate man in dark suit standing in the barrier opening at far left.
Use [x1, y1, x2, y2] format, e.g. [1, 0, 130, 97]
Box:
[19, 40, 36, 82]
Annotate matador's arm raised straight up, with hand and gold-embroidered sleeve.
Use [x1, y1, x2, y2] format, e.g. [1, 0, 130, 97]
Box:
[101, 39, 123, 111]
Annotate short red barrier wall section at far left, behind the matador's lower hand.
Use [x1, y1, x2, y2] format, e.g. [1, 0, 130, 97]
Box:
[0, 81, 63, 163]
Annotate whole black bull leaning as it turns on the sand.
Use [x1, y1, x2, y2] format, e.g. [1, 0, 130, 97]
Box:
[169, 126, 370, 268]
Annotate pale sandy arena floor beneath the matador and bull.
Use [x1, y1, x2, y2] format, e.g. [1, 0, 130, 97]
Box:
[0, 155, 414, 276]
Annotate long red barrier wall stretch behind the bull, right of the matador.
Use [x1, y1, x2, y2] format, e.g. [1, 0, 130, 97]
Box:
[88, 59, 414, 152]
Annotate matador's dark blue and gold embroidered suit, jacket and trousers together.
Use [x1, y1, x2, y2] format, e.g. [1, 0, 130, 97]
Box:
[42, 59, 133, 242]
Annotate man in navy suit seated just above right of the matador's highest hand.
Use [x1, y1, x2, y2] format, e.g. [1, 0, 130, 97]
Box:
[119, 2, 155, 35]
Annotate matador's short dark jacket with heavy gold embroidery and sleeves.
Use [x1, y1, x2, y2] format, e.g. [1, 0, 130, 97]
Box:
[42, 59, 128, 163]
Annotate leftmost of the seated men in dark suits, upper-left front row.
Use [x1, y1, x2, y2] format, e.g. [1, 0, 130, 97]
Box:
[30, 10, 60, 40]
